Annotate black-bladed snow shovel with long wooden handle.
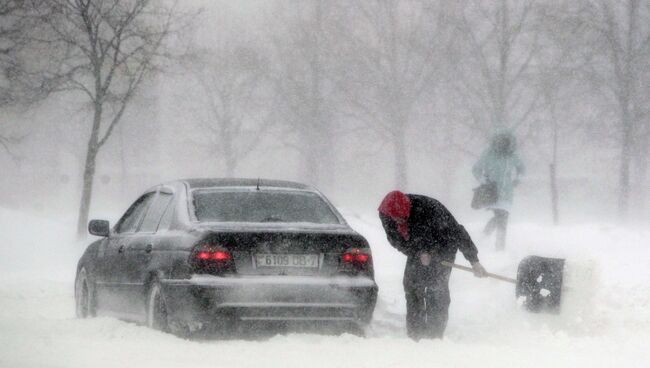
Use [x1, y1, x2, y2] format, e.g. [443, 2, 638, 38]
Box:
[441, 256, 564, 313]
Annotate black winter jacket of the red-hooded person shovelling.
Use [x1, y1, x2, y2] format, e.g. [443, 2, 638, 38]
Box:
[379, 194, 478, 288]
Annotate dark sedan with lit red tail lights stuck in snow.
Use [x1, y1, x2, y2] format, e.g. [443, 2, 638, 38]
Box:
[75, 179, 377, 334]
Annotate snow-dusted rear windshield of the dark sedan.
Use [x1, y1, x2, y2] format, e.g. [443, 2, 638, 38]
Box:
[193, 190, 340, 224]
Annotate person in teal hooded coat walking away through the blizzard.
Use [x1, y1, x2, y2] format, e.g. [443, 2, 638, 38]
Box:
[472, 132, 525, 250]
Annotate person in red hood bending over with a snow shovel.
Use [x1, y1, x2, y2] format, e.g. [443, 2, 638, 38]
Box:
[379, 191, 486, 341]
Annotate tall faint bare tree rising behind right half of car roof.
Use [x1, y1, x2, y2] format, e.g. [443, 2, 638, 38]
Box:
[272, 0, 338, 187]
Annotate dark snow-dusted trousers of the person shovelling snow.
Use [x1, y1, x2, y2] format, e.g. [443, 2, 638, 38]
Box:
[404, 264, 451, 341]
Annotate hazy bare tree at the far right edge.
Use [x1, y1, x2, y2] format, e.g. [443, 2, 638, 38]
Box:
[574, 0, 650, 219]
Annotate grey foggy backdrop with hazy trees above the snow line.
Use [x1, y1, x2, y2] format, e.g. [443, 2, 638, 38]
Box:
[0, 0, 650, 230]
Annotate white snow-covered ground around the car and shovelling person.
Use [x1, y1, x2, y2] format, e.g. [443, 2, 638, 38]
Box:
[0, 209, 650, 368]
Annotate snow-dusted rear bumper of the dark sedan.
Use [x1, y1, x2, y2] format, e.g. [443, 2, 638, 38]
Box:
[162, 275, 377, 325]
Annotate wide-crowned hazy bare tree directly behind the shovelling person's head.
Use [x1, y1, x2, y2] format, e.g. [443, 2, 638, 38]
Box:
[338, 0, 453, 188]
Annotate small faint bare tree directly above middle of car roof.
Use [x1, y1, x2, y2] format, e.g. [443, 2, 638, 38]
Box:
[182, 46, 273, 177]
